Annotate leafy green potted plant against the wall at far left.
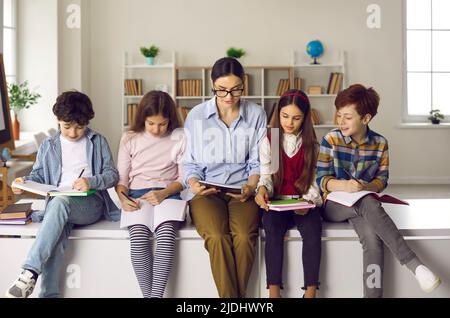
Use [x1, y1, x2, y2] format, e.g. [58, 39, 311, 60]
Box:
[8, 81, 41, 140]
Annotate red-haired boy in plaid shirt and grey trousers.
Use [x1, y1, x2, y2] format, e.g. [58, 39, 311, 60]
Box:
[317, 84, 440, 297]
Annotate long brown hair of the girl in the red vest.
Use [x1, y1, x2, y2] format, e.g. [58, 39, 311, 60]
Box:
[270, 89, 319, 195]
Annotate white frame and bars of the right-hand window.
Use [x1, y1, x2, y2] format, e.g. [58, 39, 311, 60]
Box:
[402, 0, 450, 123]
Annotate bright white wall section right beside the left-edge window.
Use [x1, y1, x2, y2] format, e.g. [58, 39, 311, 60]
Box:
[17, 0, 58, 131]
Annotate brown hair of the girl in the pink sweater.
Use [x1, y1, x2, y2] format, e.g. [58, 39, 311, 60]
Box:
[130, 91, 181, 133]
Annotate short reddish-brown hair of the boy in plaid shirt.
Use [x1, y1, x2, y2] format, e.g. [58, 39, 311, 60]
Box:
[334, 84, 380, 118]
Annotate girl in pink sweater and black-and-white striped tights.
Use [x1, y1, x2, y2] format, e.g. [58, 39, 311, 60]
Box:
[116, 91, 185, 298]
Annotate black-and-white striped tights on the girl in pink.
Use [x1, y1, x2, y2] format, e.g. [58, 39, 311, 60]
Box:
[128, 222, 178, 298]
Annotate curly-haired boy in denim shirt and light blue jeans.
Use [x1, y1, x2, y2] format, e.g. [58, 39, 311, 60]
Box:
[5, 91, 120, 298]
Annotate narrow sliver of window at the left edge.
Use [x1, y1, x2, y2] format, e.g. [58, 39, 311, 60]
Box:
[3, 0, 17, 83]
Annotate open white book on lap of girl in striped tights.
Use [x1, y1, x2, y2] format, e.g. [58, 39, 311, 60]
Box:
[120, 199, 187, 233]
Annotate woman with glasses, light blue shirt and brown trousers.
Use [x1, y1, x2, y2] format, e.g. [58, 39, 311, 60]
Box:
[184, 58, 267, 298]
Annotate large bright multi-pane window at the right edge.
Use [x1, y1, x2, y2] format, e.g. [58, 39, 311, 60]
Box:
[405, 0, 450, 121]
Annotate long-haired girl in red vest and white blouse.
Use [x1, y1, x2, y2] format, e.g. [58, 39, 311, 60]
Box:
[255, 89, 322, 298]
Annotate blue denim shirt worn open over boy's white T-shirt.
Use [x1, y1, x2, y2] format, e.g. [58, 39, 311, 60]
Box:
[23, 128, 120, 222]
